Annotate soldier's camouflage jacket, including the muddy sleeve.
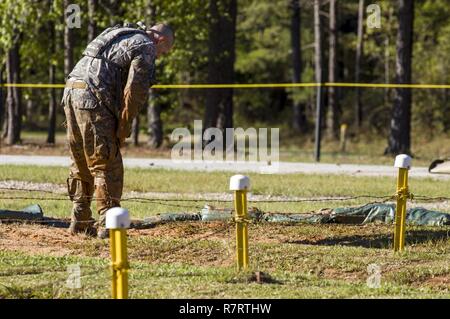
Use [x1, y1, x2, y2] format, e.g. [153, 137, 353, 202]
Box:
[68, 25, 156, 141]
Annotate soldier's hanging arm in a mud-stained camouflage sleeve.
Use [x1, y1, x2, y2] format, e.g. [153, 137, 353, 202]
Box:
[117, 49, 155, 144]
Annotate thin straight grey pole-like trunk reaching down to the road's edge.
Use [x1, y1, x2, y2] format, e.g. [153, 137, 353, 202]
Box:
[314, 0, 323, 162]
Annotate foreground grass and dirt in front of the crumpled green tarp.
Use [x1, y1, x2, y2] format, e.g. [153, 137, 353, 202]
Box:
[0, 223, 450, 298]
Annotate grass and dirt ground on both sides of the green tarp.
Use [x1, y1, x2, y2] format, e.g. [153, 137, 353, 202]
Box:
[0, 166, 450, 298]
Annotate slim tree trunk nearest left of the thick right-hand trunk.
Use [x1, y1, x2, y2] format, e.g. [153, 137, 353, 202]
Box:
[355, 0, 364, 130]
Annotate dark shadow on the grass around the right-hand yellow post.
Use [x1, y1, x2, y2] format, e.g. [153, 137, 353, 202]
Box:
[287, 230, 450, 249]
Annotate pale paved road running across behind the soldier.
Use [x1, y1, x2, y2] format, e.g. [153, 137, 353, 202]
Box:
[0, 155, 450, 179]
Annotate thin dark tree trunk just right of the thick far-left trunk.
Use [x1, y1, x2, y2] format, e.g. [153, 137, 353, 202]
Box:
[47, 1, 56, 144]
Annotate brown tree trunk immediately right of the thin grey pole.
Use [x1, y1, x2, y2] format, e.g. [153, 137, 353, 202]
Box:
[327, 0, 340, 140]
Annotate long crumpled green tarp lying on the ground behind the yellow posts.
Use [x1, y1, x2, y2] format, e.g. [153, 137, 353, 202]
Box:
[0, 203, 450, 228]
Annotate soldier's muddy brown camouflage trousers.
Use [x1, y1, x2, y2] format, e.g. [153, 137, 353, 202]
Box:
[63, 84, 123, 231]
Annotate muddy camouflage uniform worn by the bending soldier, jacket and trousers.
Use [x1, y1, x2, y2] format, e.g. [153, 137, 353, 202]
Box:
[62, 22, 156, 232]
